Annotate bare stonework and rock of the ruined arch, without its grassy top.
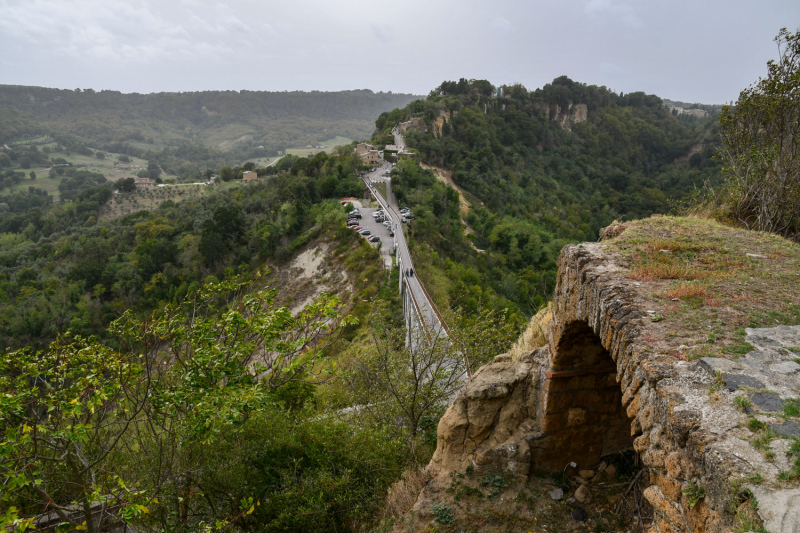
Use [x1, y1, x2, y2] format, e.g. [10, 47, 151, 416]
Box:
[410, 217, 800, 533]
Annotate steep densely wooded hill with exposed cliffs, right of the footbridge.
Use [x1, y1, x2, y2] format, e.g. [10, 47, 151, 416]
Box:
[376, 77, 719, 314]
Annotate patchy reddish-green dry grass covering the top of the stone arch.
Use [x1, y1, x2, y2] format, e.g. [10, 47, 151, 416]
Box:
[604, 212, 800, 360]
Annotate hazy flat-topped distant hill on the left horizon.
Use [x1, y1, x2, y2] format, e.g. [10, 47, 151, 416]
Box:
[0, 85, 418, 157]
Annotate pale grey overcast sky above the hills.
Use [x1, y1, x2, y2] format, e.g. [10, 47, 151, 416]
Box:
[0, 0, 800, 103]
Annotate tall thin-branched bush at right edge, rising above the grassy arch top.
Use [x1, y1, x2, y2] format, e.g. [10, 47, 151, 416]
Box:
[707, 28, 800, 240]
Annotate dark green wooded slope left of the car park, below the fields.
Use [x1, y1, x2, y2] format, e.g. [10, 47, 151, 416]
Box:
[0, 148, 372, 349]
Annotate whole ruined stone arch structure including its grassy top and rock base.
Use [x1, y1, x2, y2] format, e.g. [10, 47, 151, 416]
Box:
[396, 217, 800, 533]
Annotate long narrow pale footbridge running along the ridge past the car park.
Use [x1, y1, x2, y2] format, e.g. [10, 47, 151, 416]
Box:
[364, 162, 446, 336]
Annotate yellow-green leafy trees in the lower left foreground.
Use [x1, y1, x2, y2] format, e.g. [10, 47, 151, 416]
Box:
[0, 274, 350, 532]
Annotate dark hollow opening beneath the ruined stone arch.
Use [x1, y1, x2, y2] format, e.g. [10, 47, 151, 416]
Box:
[533, 319, 633, 470]
